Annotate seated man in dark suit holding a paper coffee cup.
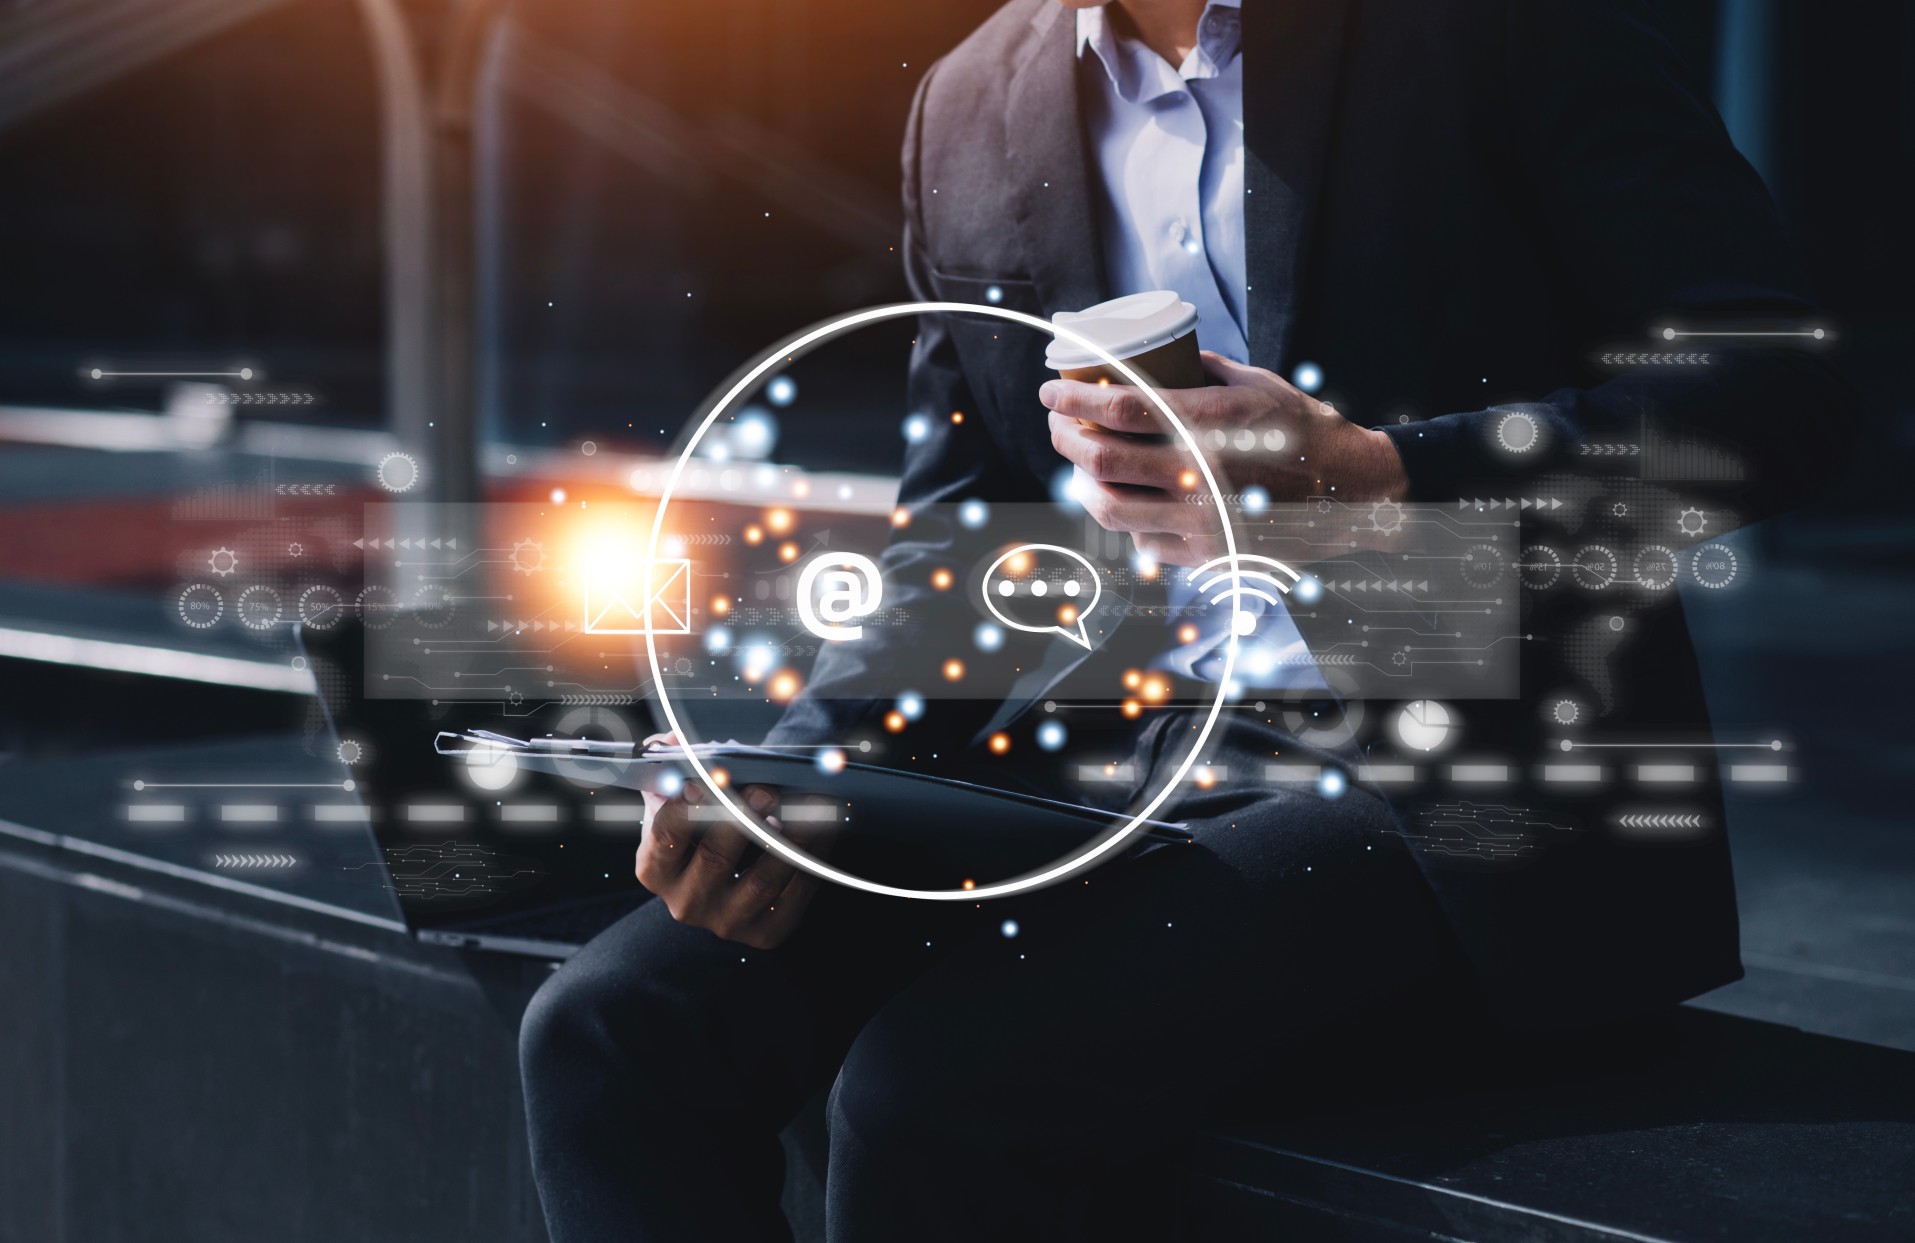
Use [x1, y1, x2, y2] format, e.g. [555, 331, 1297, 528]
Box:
[523, 0, 1852, 1241]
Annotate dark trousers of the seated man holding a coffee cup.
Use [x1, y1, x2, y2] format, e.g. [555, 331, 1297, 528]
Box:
[521, 726, 1465, 1243]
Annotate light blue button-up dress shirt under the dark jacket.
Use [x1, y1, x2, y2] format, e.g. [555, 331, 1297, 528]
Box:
[1076, 0, 1323, 689]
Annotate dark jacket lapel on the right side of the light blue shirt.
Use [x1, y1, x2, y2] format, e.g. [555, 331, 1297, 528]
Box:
[1243, 0, 1354, 373]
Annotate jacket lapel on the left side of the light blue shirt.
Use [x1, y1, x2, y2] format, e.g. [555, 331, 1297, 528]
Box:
[1003, 4, 1105, 314]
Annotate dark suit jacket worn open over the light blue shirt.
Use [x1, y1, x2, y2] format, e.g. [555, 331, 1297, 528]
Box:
[779, 0, 1852, 1027]
